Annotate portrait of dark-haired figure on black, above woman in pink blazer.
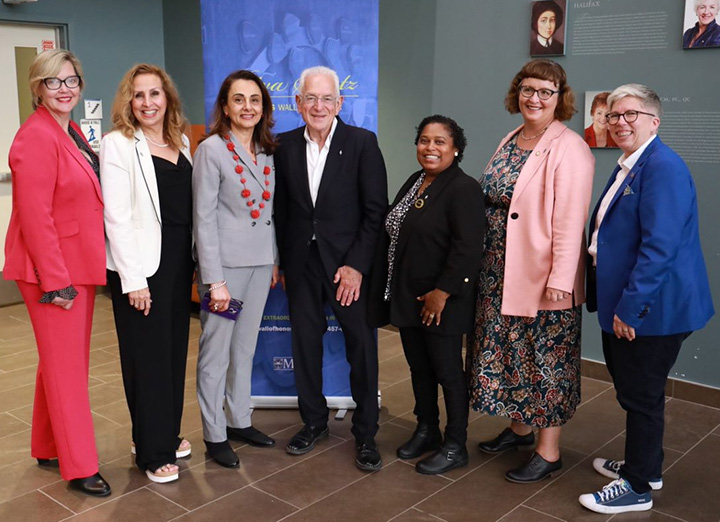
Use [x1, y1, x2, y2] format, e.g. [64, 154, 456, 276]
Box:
[530, 0, 567, 56]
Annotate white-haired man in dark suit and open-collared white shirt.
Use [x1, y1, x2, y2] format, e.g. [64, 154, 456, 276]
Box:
[275, 67, 387, 471]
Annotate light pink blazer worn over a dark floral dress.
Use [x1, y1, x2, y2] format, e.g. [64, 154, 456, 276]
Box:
[493, 120, 595, 317]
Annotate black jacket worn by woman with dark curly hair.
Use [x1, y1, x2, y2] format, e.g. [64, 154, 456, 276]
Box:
[369, 162, 485, 335]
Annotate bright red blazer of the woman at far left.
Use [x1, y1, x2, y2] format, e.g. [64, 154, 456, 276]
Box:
[3, 107, 105, 292]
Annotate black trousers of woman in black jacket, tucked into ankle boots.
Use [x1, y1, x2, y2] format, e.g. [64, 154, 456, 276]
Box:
[400, 328, 469, 440]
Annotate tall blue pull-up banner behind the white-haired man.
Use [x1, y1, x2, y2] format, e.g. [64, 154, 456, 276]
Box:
[200, 0, 379, 402]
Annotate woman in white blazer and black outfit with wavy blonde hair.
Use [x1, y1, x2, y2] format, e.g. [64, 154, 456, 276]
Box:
[100, 64, 194, 482]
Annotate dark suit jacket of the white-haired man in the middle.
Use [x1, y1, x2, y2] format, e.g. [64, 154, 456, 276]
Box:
[274, 118, 387, 279]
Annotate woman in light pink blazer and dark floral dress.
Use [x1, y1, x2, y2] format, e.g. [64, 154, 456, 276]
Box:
[467, 59, 595, 483]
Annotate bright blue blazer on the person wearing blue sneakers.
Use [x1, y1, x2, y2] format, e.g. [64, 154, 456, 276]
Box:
[587, 137, 715, 335]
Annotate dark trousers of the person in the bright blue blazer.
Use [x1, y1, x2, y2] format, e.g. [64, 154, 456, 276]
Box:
[602, 332, 689, 493]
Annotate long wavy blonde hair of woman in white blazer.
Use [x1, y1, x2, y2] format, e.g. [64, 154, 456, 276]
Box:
[111, 63, 187, 150]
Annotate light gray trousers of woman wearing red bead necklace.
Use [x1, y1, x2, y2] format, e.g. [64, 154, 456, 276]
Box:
[197, 265, 273, 442]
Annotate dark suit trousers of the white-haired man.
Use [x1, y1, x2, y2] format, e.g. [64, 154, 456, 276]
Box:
[287, 242, 379, 442]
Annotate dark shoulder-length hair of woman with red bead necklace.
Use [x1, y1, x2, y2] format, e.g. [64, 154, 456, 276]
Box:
[208, 69, 278, 155]
